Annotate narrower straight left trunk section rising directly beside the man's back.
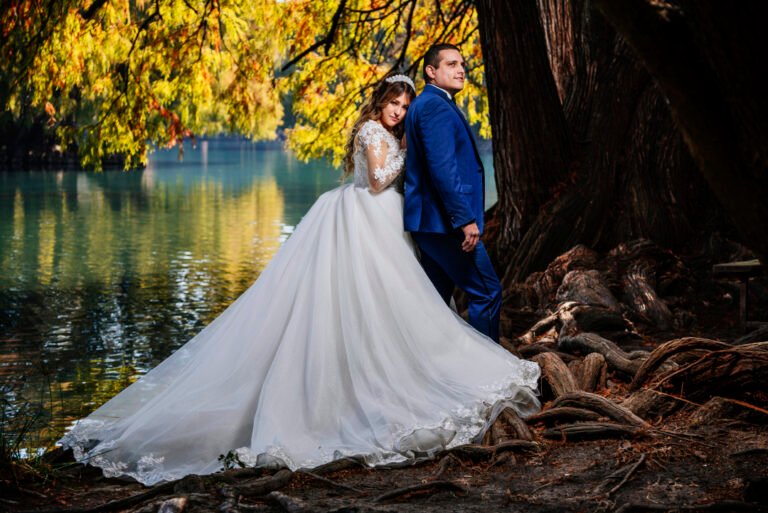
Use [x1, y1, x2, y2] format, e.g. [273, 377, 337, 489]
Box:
[476, 0, 569, 260]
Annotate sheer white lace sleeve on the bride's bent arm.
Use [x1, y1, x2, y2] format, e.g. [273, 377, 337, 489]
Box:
[358, 121, 405, 192]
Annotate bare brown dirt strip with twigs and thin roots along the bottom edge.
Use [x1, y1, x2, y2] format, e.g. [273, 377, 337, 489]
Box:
[0, 414, 768, 513]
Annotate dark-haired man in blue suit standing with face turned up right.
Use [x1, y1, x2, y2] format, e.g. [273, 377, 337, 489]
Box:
[404, 44, 501, 342]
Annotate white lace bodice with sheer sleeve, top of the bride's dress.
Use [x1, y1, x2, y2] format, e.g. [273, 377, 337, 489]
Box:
[354, 120, 405, 190]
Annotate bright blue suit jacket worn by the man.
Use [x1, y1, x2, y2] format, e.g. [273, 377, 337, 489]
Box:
[404, 85, 485, 233]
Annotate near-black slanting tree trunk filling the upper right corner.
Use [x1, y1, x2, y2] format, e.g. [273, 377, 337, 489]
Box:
[595, 0, 768, 268]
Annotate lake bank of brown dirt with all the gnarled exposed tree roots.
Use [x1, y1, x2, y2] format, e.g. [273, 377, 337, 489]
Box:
[0, 241, 768, 513]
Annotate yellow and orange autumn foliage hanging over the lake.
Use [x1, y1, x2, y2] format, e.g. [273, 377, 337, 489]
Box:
[0, 0, 490, 168]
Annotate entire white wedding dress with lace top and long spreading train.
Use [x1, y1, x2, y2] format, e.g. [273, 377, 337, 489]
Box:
[60, 121, 539, 485]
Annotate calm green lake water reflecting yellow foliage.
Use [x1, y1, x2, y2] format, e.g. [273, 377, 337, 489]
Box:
[0, 139, 496, 447]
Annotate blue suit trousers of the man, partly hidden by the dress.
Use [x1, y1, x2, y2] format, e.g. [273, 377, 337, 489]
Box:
[411, 232, 501, 342]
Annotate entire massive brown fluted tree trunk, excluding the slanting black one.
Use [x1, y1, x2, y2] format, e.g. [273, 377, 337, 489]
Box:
[477, 0, 729, 285]
